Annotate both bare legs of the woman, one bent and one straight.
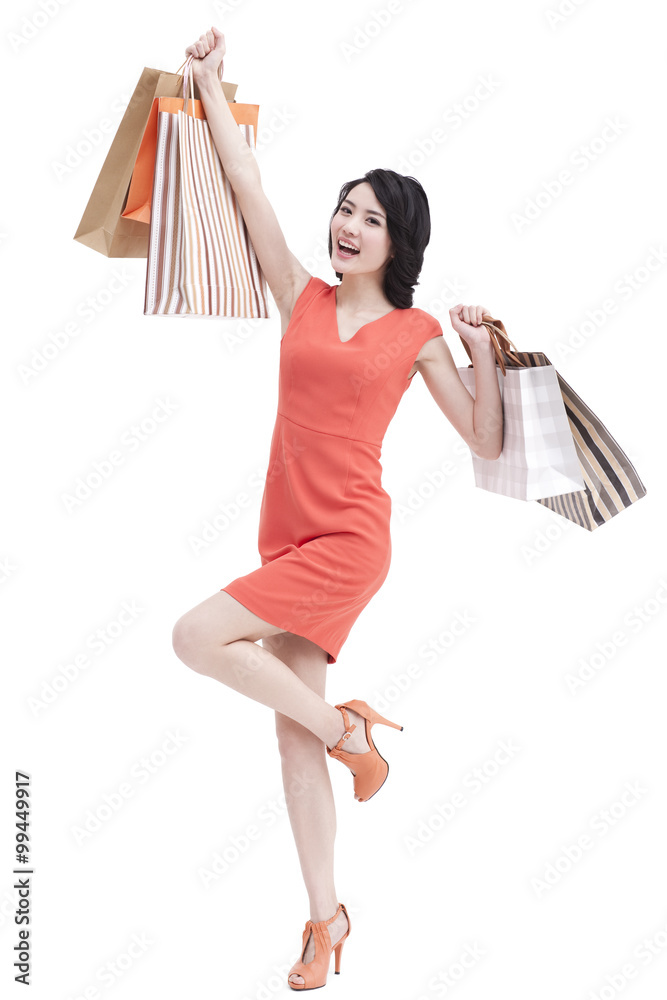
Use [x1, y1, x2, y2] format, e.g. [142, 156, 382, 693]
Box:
[173, 591, 360, 983]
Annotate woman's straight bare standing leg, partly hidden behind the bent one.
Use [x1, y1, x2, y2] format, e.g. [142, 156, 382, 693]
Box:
[262, 633, 347, 983]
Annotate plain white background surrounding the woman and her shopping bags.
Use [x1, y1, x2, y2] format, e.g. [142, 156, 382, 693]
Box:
[0, 0, 667, 1000]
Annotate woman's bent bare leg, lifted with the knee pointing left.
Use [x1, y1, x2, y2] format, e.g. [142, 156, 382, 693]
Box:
[172, 590, 369, 753]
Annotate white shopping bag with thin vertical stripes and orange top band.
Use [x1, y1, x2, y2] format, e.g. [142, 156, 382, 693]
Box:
[144, 59, 269, 319]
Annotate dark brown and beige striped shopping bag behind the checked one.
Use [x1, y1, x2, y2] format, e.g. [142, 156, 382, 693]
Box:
[459, 317, 646, 531]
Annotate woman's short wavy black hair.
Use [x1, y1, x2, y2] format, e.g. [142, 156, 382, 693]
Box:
[329, 168, 431, 309]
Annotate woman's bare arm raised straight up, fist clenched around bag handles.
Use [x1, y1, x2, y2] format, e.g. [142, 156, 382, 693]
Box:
[185, 28, 311, 320]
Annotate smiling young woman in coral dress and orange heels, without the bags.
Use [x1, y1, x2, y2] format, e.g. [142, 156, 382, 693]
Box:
[173, 28, 503, 989]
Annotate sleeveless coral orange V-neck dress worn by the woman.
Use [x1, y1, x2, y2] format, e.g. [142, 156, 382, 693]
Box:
[220, 277, 443, 663]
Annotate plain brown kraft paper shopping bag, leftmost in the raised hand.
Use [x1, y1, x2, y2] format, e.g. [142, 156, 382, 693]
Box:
[74, 61, 236, 257]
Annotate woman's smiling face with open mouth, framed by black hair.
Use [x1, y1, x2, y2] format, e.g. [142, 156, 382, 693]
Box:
[331, 181, 392, 275]
